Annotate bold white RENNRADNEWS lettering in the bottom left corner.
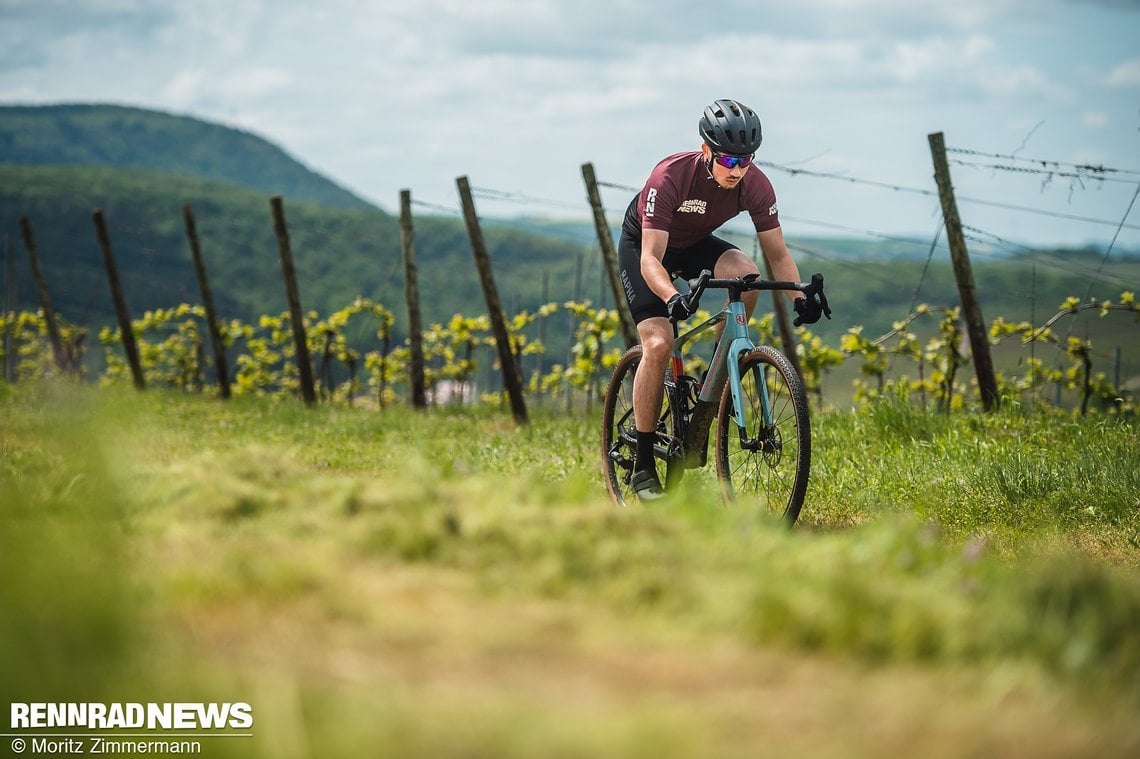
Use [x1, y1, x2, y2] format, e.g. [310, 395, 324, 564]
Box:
[8, 701, 253, 731]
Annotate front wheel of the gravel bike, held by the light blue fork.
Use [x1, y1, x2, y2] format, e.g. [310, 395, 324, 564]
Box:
[716, 345, 812, 524]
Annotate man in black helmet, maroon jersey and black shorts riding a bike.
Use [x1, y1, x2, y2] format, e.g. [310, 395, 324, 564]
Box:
[618, 99, 821, 500]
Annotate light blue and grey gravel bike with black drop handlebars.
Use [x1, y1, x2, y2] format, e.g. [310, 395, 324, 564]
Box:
[602, 270, 831, 524]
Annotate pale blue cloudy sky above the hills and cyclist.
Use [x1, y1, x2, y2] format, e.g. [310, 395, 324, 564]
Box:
[0, 0, 1140, 251]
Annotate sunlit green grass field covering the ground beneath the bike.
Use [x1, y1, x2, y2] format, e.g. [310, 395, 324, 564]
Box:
[0, 386, 1140, 757]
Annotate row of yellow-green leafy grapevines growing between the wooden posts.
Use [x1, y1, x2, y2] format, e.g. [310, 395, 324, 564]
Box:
[0, 283, 1140, 414]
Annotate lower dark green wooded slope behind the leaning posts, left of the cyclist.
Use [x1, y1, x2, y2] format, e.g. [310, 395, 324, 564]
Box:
[0, 166, 599, 341]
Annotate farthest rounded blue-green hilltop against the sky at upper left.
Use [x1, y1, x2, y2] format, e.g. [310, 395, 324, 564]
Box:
[0, 105, 369, 209]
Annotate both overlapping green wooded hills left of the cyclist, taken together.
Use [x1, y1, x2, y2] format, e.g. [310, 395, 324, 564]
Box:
[0, 105, 601, 332]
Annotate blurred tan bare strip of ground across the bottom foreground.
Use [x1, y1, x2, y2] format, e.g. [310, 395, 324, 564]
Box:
[163, 560, 1140, 758]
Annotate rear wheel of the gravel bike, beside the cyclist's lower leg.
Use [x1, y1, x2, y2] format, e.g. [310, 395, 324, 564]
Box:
[602, 345, 684, 506]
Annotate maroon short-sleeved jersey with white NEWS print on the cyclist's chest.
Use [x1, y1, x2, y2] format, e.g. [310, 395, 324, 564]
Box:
[624, 152, 780, 247]
